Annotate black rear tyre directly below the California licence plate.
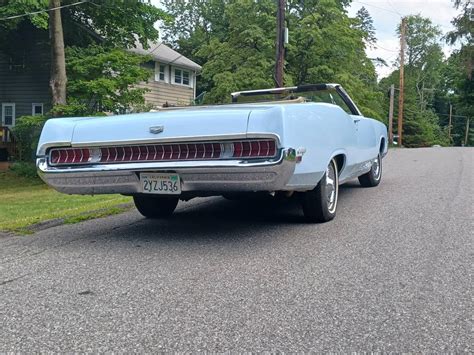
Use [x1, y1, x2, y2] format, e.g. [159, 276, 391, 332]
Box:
[133, 195, 179, 218]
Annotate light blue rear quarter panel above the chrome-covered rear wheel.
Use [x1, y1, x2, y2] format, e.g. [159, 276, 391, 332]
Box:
[247, 103, 360, 190]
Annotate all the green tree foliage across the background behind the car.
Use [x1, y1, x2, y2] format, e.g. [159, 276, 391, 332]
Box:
[0, 0, 474, 147]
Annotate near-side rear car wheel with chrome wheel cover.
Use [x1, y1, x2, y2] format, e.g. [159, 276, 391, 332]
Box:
[303, 159, 339, 222]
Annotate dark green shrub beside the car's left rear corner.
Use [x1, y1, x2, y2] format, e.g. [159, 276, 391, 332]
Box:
[12, 116, 48, 162]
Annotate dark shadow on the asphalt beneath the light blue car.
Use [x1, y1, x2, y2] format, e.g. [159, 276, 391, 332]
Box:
[106, 183, 360, 240]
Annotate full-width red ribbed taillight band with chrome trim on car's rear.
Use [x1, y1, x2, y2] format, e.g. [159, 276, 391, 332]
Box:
[49, 139, 277, 165]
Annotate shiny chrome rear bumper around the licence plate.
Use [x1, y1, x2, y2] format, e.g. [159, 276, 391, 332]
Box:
[36, 148, 296, 195]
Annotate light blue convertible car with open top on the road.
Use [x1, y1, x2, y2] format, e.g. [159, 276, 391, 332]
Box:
[37, 84, 387, 222]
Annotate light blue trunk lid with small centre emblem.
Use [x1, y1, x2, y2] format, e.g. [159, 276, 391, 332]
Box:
[71, 106, 251, 146]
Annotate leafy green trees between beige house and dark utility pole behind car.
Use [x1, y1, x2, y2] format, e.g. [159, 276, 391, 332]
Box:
[164, 0, 276, 102]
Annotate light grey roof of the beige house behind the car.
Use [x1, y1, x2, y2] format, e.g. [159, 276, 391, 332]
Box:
[129, 41, 202, 71]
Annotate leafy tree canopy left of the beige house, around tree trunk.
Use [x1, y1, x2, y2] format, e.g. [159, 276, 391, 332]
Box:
[0, 0, 168, 114]
